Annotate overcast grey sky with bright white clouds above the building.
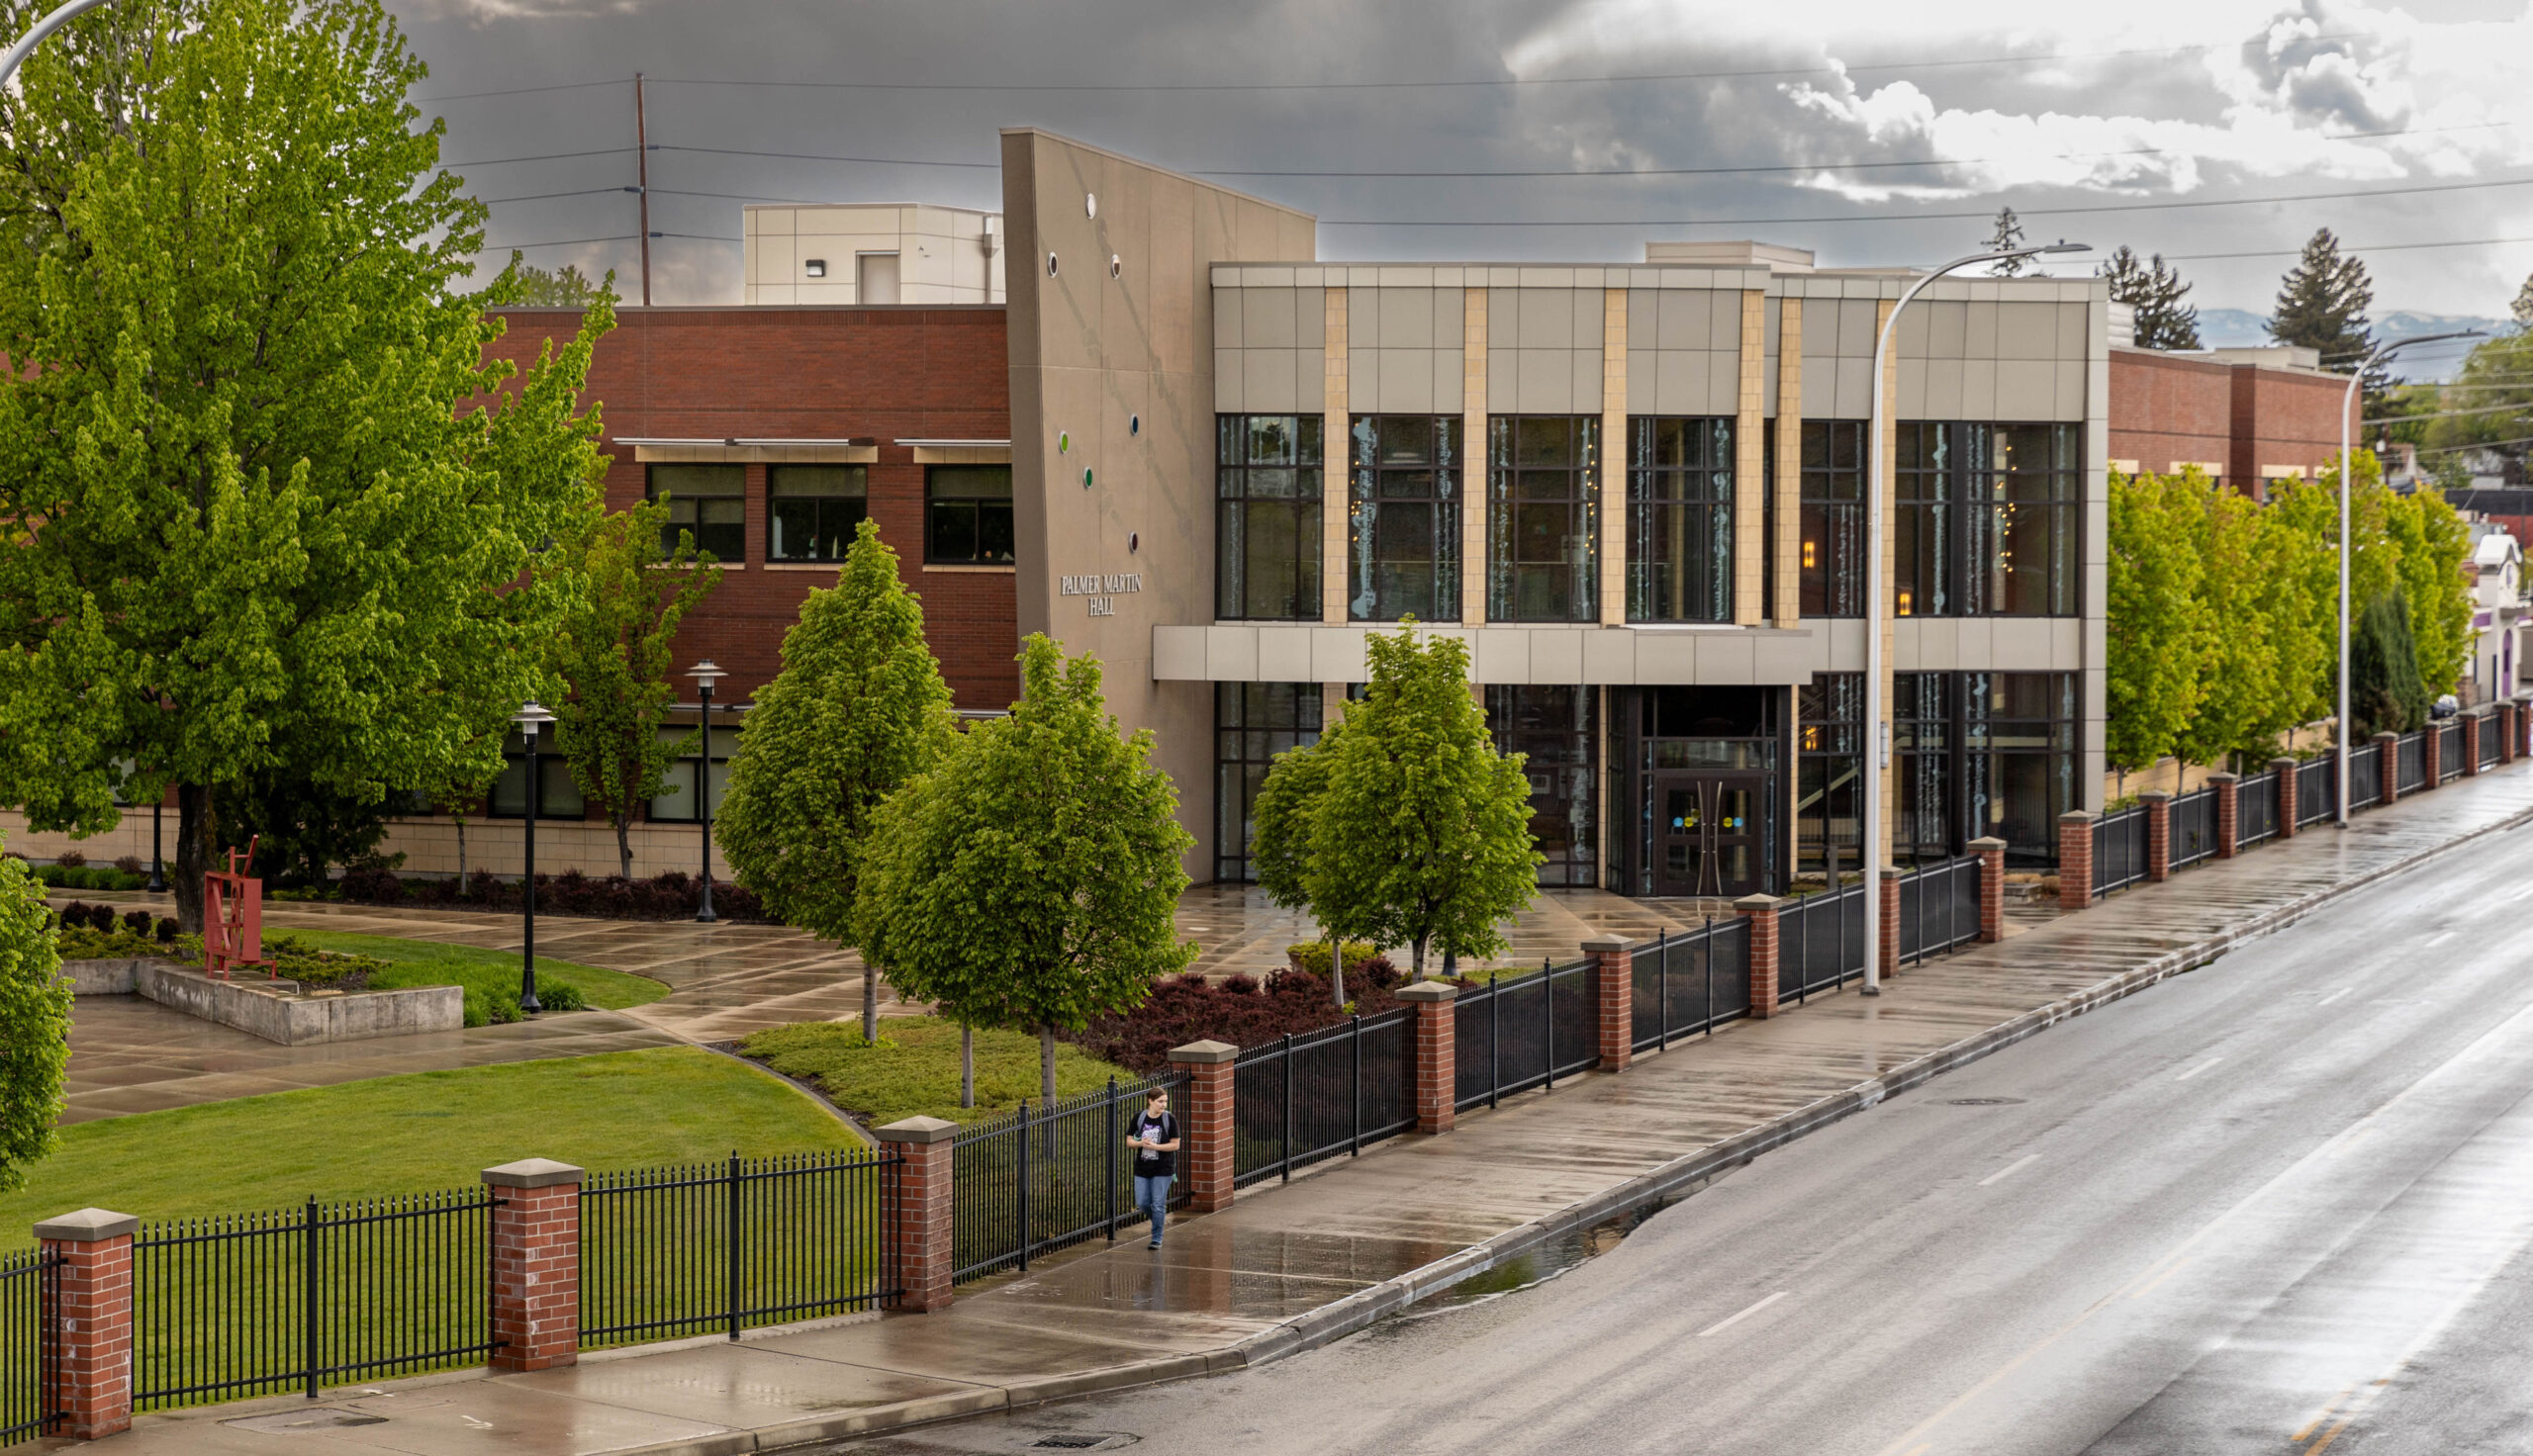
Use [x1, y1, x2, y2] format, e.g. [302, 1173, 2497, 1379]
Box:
[390, 0, 2533, 356]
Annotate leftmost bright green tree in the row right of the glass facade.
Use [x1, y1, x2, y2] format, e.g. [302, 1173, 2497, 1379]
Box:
[2103, 474, 2208, 773]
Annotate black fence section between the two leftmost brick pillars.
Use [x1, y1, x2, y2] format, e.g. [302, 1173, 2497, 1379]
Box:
[132, 1188, 494, 1410]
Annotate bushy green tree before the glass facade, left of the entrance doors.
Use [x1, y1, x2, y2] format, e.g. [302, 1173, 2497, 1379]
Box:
[1317, 623, 1543, 980]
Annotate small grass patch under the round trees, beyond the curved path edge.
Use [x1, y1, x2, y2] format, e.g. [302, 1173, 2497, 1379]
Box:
[740, 1016, 1143, 1127]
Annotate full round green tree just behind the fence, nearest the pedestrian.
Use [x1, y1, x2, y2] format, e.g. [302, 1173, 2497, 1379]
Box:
[856, 633, 1195, 1099]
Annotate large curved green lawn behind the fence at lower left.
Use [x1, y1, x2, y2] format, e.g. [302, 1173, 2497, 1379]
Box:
[0, 1047, 854, 1248]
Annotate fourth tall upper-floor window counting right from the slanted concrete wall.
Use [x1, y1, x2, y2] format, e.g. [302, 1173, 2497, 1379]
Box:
[1627, 415, 1733, 623]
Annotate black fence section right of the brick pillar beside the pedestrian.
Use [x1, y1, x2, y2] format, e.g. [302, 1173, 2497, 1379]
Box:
[1231, 1008, 1416, 1188]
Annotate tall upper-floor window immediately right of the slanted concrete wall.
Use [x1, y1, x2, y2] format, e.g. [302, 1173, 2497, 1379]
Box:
[1213, 415, 1322, 623]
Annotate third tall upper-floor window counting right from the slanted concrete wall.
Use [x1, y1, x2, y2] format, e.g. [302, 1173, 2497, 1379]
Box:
[1487, 415, 1601, 623]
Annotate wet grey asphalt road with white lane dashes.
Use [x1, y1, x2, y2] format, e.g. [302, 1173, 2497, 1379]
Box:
[838, 828, 2533, 1456]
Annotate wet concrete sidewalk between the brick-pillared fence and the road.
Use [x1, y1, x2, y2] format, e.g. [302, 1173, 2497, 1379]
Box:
[73, 765, 2533, 1456]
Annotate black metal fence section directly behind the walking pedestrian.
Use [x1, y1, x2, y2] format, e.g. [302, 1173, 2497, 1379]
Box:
[950, 1073, 1188, 1281]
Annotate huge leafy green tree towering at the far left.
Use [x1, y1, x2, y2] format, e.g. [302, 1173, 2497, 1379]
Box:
[0, 0, 613, 930]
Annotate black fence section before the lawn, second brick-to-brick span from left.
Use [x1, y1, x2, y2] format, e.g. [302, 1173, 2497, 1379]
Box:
[580, 1147, 899, 1349]
